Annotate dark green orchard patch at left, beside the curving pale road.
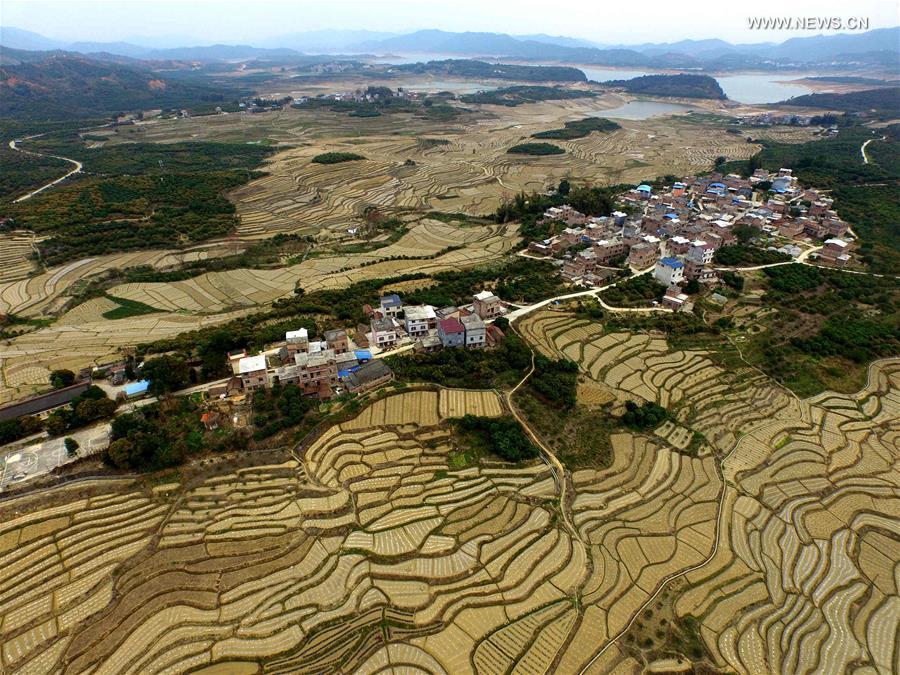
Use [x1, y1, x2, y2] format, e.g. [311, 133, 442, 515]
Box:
[6, 136, 271, 265]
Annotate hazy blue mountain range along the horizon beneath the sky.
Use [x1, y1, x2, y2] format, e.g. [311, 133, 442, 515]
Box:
[0, 26, 900, 70]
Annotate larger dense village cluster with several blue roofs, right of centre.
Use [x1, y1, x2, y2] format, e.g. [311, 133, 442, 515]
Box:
[528, 169, 851, 298]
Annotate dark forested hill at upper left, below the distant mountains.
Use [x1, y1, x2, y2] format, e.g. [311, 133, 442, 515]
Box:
[0, 53, 246, 120]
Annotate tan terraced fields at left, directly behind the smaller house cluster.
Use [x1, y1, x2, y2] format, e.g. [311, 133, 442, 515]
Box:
[0, 219, 518, 403]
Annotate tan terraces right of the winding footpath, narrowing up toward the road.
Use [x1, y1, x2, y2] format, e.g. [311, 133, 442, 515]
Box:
[521, 312, 900, 674]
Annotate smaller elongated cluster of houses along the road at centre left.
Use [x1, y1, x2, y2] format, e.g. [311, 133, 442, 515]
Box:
[228, 291, 506, 400]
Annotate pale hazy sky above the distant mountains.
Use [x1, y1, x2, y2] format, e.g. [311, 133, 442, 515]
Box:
[0, 0, 900, 44]
